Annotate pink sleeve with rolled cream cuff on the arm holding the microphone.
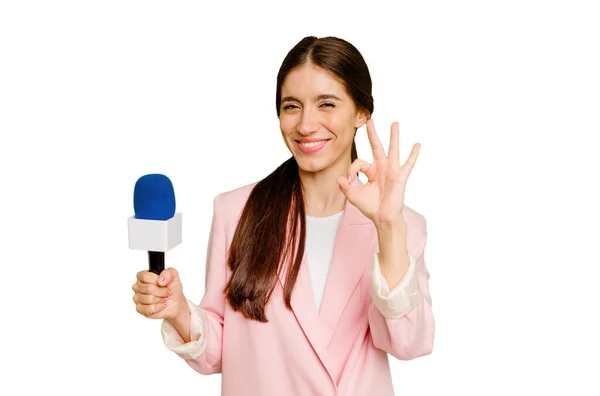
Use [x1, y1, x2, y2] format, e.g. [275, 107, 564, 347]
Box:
[161, 195, 227, 375]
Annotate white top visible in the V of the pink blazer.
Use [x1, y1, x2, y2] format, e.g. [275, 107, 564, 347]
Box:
[304, 211, 344, 311]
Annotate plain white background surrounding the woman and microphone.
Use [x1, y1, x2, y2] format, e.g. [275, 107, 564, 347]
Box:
[0, 0, 600, 395]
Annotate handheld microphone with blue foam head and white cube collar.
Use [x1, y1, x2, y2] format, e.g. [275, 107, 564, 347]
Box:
[127, 173, 181, 275]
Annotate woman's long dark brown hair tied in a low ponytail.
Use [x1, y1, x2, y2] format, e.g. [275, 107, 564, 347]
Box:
[223, 36, 373, 322]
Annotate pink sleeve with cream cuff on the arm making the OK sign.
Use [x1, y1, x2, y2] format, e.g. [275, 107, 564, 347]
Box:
[368, 218, 435, 360]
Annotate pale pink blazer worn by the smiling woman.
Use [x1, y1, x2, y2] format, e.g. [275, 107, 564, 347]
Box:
[163, 179, 435, 396]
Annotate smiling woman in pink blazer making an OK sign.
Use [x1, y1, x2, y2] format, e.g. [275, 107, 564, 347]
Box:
[133, 37, 434, 396]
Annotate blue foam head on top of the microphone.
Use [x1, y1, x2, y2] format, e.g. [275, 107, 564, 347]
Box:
[133, 174, 175, 220]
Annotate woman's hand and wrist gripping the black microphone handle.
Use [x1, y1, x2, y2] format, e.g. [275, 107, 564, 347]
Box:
[131, 268, 190, 342]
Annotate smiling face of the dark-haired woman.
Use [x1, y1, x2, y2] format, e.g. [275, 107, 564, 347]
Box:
[279, 62, 366, 172]
